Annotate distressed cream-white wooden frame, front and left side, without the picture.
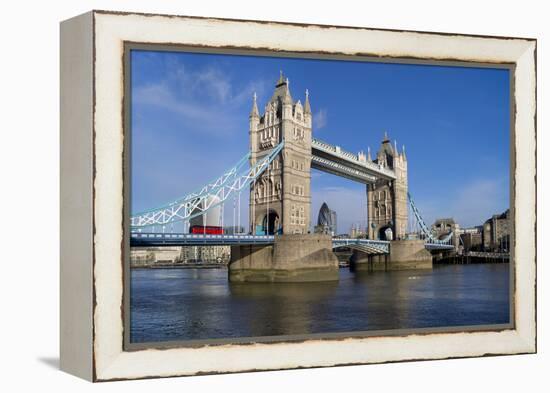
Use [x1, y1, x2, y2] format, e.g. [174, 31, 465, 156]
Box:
[60, 11, 536, 381]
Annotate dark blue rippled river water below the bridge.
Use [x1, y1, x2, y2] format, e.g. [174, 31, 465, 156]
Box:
[130, 263, 510, 343]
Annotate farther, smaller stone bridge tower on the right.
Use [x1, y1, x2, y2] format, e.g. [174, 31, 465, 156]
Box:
[367, 133, 408, 240]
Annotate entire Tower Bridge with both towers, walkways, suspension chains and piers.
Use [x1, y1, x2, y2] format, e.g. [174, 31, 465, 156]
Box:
[130, 72, 453, 281]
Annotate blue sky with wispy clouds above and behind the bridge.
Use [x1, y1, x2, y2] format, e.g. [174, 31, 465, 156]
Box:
[131, 50, 510, 233]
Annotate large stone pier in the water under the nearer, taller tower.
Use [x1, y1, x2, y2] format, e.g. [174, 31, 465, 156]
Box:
[229, 234, 338, 282]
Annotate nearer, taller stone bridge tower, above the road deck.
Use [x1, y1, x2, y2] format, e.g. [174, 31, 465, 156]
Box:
[249, 72, 312, 234]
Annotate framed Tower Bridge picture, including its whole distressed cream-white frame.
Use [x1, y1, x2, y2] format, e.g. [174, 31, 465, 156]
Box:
[60, 11, 536, 381]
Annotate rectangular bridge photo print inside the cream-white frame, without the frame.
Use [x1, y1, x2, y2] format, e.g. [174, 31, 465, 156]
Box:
[125, 48, 513, 346]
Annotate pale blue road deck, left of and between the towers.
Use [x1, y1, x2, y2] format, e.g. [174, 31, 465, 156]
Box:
[130, 232, 390, 254]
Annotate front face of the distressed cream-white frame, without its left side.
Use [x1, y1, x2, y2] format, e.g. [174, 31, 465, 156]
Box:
[62, 12, 536, 380]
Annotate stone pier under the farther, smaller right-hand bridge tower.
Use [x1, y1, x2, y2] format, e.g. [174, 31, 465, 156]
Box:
[351, 240, 433, 271]
